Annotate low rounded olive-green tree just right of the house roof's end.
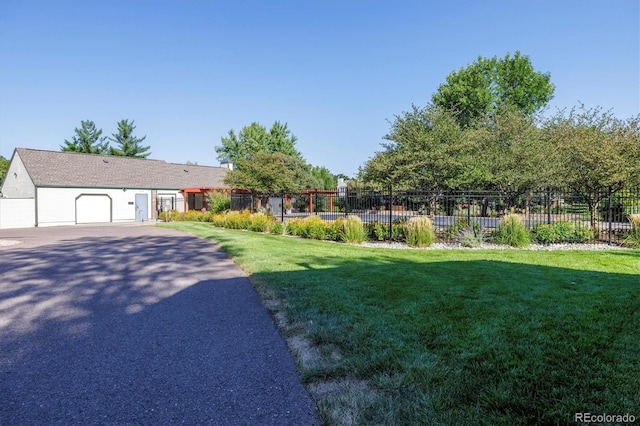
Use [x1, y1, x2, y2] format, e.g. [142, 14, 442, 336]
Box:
[224, 152, 300, 194]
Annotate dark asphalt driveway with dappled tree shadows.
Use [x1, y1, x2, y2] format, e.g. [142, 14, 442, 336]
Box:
[0, 225, 320, 425]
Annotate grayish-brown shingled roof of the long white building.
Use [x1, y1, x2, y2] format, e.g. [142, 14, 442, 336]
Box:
[16, 148, 228, 189]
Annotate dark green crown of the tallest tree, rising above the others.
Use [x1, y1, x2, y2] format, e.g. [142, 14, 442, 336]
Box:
[432, 52, 554, 127]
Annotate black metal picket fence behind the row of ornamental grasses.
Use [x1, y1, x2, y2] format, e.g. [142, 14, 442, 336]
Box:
[231, 187, 640, 244]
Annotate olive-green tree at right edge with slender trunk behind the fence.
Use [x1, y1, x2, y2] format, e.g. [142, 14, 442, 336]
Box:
[543, 105, 640, 229]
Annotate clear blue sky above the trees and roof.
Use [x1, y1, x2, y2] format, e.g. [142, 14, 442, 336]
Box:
[0, 0, 640, 176]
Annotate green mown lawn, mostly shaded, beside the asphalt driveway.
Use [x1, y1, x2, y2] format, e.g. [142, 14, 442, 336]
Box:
[160, 223, 640, 425]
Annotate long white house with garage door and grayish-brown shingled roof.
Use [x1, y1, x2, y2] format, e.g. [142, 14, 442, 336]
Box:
[0, 148, 229, 228]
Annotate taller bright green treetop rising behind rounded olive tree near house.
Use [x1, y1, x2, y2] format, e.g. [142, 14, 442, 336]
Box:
[215, 121, 302, 164]
